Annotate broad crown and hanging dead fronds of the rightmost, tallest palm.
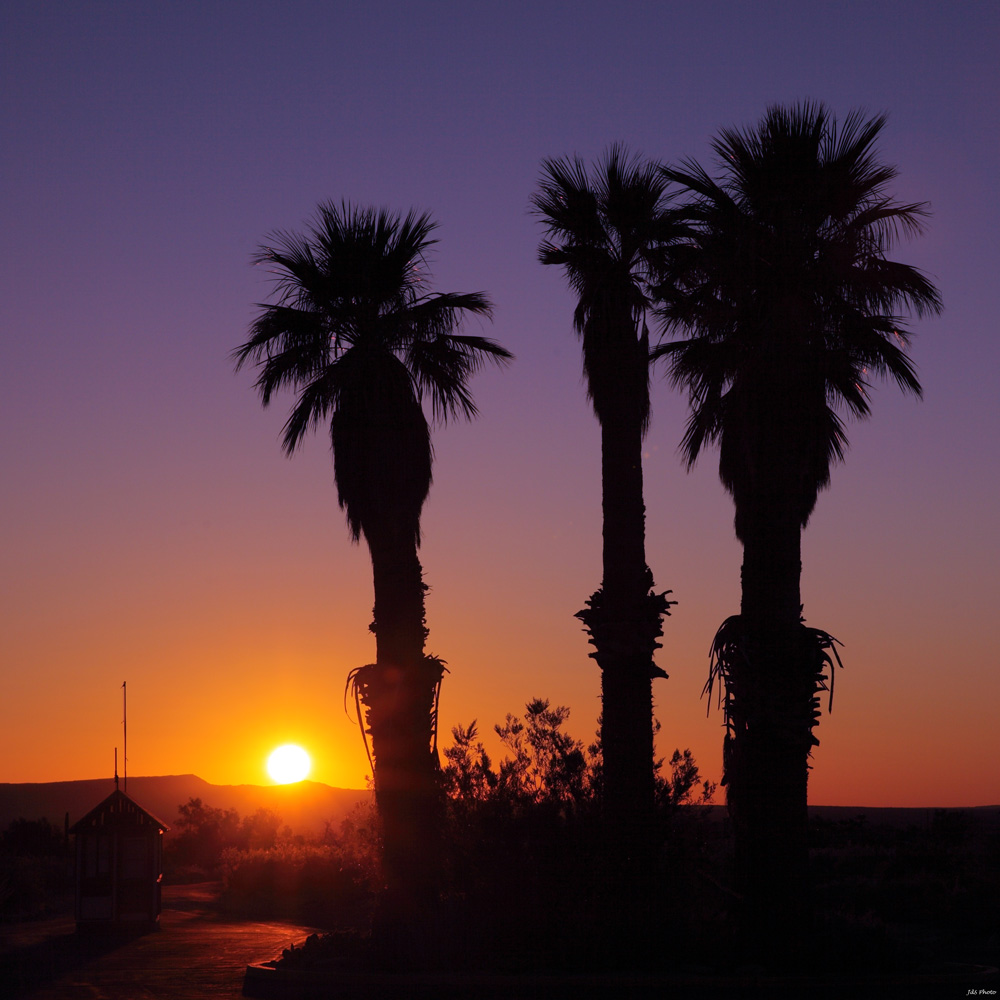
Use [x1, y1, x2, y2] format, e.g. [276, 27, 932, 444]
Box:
[654, 104, 940, 537]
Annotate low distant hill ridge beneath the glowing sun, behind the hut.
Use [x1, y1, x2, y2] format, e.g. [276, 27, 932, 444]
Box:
[0, 774, 371, 835]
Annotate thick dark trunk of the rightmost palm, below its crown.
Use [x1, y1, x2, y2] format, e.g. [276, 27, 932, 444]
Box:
[727, 508, 814, 962]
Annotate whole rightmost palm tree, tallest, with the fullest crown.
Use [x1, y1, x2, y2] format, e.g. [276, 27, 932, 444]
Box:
[653, 103, 941, 960]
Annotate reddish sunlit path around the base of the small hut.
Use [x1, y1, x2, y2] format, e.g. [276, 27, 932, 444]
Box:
[0, 883, 315, 1000]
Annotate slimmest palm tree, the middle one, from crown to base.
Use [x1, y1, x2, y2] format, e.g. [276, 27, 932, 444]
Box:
[532, 146, 672, 877]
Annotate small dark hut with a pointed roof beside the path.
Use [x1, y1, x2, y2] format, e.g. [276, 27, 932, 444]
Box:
[70, 780, 170, 931]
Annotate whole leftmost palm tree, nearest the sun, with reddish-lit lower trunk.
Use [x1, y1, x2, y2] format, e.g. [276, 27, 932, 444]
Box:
[234, 203, 511, 912]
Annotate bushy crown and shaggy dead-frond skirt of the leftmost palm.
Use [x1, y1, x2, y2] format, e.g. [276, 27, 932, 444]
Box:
[235, 203, 511, 541]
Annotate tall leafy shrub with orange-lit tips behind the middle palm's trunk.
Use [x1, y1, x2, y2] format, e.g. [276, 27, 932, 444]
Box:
[443, 699, 714, 971]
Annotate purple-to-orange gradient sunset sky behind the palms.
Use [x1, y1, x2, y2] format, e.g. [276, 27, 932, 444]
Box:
[0, 0, 1000, 806]
